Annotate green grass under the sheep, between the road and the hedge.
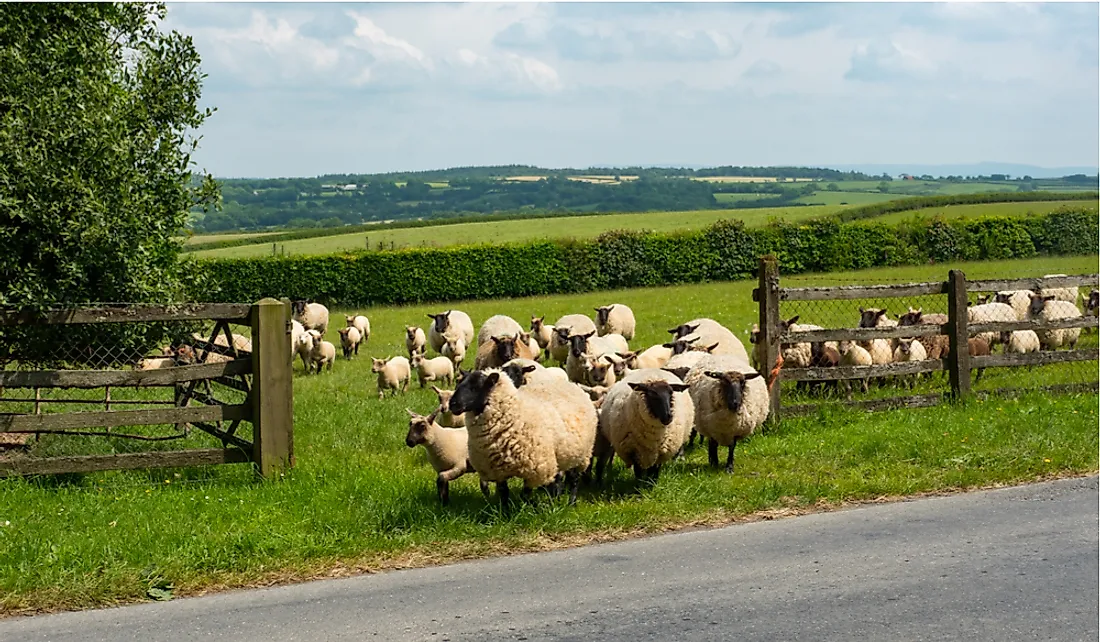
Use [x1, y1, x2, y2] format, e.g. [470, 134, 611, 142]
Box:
[0, 256, 1100, 613]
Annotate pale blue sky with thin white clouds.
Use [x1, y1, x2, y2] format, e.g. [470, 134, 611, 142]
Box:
[162, 2, 1100, 177]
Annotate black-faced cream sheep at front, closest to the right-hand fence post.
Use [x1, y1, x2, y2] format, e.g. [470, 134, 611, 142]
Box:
[684, 354, 770, 473]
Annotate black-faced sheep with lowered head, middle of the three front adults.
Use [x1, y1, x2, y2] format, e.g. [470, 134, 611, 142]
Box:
[594, 368, 695, 484]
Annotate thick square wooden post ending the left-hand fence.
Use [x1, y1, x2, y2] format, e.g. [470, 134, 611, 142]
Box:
[252, 298, 294, 479]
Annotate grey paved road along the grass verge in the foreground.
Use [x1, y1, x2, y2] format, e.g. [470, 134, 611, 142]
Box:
[0, 477, 1100, 642]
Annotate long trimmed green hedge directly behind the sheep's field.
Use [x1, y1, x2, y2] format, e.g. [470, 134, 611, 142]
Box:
[195, 208, 1100, 307]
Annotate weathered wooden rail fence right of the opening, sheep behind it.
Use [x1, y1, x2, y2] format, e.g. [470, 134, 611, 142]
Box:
[752, 256, 1100, 421]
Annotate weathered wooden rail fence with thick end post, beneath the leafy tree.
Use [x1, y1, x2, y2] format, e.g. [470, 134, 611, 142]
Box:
[0, 299, 294, 478]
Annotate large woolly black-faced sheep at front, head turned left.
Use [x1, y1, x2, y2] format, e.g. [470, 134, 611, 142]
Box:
[448, 368, 564, 511]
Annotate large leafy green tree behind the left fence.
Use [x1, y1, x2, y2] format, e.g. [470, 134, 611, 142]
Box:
[0, 2, 218, 306]
